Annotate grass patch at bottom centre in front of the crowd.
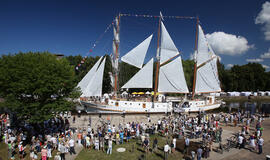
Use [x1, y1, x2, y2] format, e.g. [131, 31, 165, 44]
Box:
[76, 136, 182, 160]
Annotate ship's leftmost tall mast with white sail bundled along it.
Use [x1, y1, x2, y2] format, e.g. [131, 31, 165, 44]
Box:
[114, 14, 120, 98]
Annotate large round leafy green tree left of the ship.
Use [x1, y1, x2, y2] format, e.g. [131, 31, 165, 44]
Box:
[0, 52, 80, 123]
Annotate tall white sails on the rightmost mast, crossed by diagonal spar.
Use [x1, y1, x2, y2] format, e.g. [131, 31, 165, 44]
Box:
[195, 25, 221, 93]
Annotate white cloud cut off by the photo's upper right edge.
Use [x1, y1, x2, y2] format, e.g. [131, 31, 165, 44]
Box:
[255, 2, 270, 40]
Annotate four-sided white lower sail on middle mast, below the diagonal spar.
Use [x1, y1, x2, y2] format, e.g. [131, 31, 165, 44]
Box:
[158, 56, 188, 93]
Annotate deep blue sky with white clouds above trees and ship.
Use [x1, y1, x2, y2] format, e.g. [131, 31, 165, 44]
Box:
[0, 0, 270, 71]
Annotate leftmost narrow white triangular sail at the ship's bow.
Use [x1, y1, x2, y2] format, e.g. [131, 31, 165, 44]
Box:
[77, 56, 103, 92]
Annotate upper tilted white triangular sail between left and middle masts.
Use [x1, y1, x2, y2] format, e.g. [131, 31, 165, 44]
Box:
[121, 34, 153, 68]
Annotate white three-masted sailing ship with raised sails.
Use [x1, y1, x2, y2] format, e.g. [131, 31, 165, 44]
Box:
[78, 15, 220, 113]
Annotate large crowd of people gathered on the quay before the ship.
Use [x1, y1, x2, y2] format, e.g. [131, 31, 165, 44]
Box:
[0, 109, 264, 160]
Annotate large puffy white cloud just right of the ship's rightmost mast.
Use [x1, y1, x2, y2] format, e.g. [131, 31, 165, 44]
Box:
[206, 32, 254, 56]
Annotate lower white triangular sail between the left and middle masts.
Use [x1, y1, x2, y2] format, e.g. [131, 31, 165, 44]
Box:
[122, 58, 154, 88]
